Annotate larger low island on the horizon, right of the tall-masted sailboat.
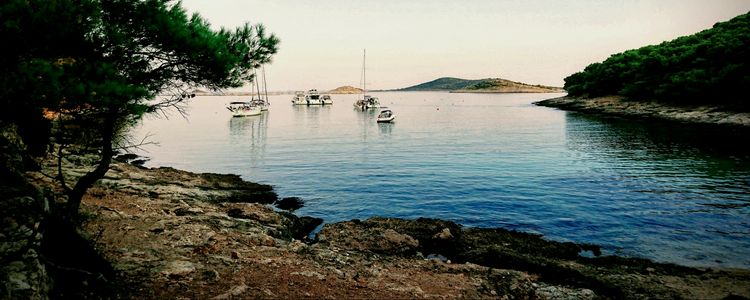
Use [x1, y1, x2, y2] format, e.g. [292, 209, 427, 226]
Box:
[398, 77, 564, 93]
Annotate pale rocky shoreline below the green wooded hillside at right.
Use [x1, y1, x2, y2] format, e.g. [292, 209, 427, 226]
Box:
[534, 96, 750, 128]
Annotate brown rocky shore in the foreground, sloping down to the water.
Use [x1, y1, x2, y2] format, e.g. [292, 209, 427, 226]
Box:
[14, 159, 750, 299]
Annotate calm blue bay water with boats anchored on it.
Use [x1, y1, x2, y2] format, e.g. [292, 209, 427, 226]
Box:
[135, 92, 750, 268]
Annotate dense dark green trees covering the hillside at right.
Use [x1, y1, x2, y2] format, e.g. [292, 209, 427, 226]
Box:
[564, 13, 750, 110]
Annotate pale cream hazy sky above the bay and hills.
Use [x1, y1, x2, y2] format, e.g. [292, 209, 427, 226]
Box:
[182, 0, 750, 91]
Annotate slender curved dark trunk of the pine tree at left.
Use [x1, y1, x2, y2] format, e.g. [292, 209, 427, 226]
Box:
[67, 114, 116, 220]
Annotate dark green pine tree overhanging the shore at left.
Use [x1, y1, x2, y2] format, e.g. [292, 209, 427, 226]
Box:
[0, 0, 279, 219]
